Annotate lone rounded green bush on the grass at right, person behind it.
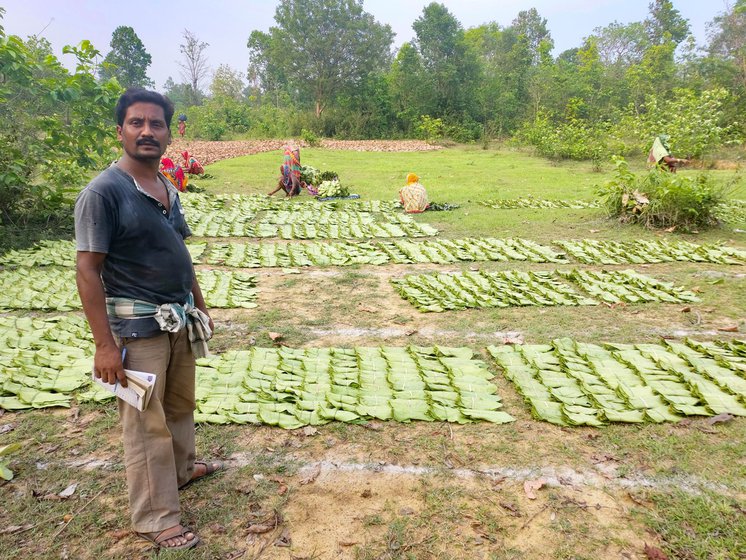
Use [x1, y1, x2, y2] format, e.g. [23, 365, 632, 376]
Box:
[596, 156, 726, 230]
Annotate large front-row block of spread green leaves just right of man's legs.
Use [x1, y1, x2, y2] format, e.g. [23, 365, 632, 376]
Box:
[195, 346, 513, 429]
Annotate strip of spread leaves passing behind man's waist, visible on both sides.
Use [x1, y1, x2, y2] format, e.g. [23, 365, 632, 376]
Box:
[0, 267, 258, 311]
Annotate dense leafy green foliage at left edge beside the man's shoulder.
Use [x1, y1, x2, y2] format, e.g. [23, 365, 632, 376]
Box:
[0, 32, 121, 235]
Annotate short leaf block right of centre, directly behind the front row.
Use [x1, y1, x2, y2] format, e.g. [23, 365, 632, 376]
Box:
[391, 270, 699, 312]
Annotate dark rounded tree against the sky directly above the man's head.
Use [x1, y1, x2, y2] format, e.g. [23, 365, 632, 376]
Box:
[100, 25, 154, 88]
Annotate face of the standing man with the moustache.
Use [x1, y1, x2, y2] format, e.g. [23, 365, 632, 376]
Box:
[117, 101, 171, 162]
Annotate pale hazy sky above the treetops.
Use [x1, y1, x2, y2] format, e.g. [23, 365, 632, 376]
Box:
[1, 0, 727, 89]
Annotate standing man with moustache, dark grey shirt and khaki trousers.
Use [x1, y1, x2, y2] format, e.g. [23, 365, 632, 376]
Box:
[75, 88, 223, 549]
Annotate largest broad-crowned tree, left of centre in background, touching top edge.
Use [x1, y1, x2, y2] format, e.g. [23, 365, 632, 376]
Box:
[248, 0, 393, 118]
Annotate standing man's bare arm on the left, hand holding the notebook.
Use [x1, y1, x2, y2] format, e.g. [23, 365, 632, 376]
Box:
[75, 251, 127, 387]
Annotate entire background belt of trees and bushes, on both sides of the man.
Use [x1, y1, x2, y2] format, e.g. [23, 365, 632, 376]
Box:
[0, 0, 746, 245]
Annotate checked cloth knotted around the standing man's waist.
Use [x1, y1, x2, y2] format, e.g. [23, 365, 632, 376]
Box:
[106, 293, 212, 358]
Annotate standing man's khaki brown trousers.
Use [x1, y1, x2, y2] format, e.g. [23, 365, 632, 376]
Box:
[119, 329, 195, 533]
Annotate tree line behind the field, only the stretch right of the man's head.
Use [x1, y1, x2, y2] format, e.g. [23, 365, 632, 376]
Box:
[167, 0, 746, 160]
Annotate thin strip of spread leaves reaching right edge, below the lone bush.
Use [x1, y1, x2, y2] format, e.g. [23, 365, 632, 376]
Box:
[555, 239, 746, 265]
